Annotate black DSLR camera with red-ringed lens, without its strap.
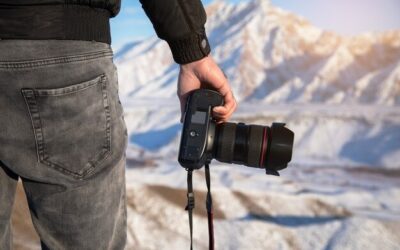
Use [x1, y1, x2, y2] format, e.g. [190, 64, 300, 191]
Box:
[178, 89, 294, 175]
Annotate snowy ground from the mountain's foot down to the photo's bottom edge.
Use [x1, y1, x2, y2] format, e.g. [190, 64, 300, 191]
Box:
[117, 98, 400, 250]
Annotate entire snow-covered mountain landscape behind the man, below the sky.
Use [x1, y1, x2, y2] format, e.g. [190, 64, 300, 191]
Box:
[112, 1, 400, 250]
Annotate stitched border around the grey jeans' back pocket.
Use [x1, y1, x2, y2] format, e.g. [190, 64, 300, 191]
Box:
[21, 74, 111, 179]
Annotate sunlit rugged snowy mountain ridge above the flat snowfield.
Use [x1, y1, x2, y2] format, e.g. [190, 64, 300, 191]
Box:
[116, 0, 400, 106]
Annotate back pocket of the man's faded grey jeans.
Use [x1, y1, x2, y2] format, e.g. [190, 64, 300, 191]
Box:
[21, 75, 111, 179]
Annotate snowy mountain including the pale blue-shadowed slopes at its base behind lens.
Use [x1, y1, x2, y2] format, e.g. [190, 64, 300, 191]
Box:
[115, 0, 400, 168]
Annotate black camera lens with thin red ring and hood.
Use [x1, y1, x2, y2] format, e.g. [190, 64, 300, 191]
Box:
[214, 123, 294, 173]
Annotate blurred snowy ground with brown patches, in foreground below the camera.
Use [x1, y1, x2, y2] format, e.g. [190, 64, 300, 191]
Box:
[127, 160, 400, 249]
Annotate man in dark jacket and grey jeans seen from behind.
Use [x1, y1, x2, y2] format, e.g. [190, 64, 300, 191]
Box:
[0, 0, 236, 250]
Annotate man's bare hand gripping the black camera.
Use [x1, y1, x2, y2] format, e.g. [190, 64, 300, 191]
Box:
[177, 56, 237, 123]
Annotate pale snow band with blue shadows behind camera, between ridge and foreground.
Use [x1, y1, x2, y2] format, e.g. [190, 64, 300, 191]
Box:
[124, 98, 400, 169]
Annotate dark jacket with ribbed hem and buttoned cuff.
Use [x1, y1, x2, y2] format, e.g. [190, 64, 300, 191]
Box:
[0, 0, 210, 64]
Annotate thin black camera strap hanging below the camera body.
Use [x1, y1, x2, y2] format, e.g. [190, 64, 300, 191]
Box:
[185, 163, 214, 250]
